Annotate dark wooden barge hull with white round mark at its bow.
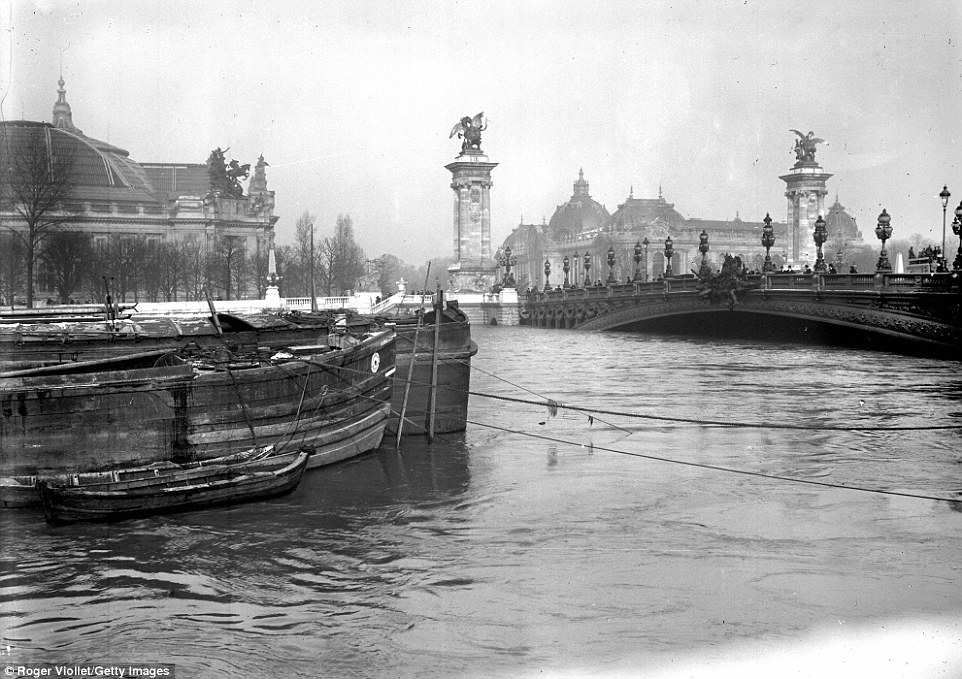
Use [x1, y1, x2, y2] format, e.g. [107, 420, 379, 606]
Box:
[0, 331, 395, 502]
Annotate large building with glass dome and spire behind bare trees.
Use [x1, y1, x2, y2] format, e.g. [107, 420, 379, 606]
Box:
[0, 78, 278, 304]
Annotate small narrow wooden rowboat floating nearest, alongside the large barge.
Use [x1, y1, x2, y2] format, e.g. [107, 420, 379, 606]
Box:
[37, 450, 310, 523]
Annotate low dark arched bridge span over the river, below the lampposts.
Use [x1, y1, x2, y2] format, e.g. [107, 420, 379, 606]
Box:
[521, 272, 962, 359]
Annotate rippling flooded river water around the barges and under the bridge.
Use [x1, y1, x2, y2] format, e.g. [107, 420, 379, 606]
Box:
[0, 327, 962, 678]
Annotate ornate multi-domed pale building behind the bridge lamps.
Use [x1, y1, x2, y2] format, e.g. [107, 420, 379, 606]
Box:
[497, 161, 861, 288]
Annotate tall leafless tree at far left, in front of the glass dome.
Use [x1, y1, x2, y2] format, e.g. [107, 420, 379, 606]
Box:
[0, 125, 76, 308]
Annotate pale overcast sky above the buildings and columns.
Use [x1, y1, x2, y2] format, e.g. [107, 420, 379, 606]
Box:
[0, 0, 962, 264]
